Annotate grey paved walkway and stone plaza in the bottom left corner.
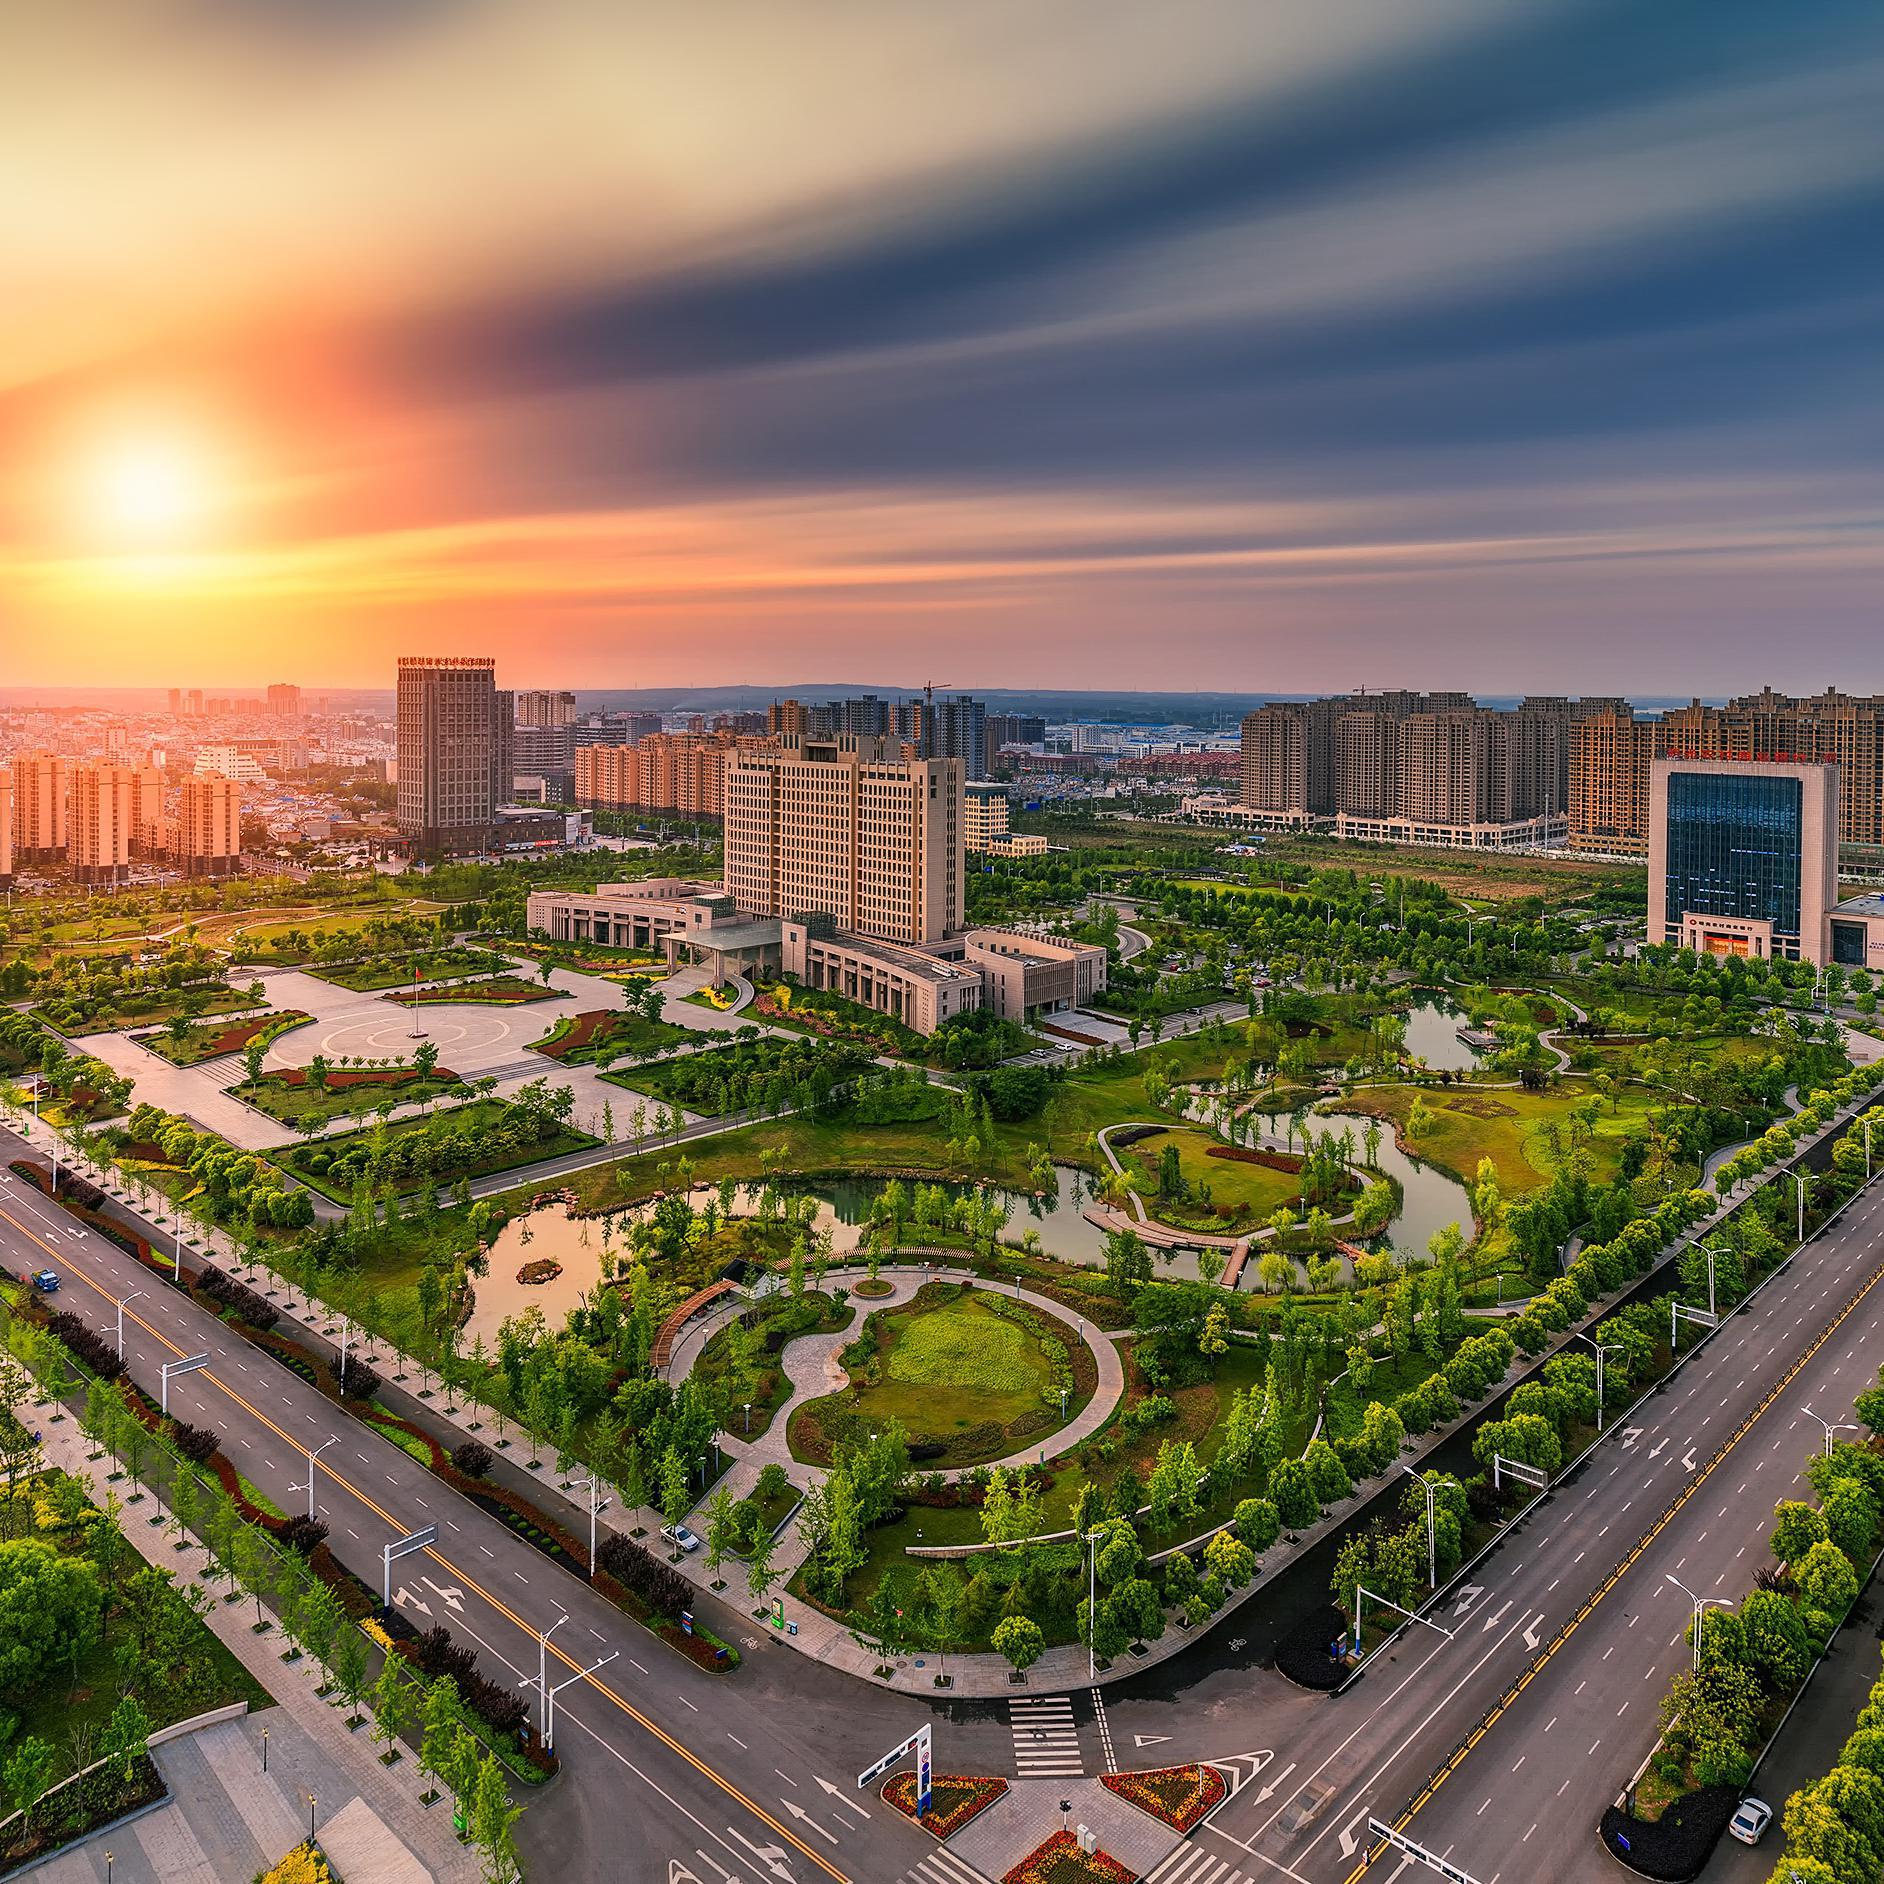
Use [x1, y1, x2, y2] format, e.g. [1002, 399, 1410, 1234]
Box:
[34, 1419, 480, 1884]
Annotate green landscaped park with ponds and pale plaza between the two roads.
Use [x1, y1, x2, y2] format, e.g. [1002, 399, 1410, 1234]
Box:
[0, 827, 1875, 1679]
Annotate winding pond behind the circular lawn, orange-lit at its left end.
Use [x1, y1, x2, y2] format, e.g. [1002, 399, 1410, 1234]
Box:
[458, 1164, 1106, 1349]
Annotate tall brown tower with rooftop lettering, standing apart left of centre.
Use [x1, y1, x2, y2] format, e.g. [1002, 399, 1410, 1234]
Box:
[396, 656, 514, 852]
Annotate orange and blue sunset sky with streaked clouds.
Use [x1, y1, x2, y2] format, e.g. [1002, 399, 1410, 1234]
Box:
[0, 0, 1884, 693]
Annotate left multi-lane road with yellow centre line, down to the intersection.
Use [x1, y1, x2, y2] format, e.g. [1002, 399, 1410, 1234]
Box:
[0, 1132, 1012, 1884]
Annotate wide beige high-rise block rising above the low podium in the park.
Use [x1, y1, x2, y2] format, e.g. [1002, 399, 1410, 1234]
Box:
[725, 735, 965, 944]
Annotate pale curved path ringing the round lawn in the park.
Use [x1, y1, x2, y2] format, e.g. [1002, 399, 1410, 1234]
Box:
[667, 1251, 1125, 1481]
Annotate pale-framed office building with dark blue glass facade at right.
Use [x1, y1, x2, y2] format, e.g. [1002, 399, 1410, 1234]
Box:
[1649, 759, 1839, 963]
